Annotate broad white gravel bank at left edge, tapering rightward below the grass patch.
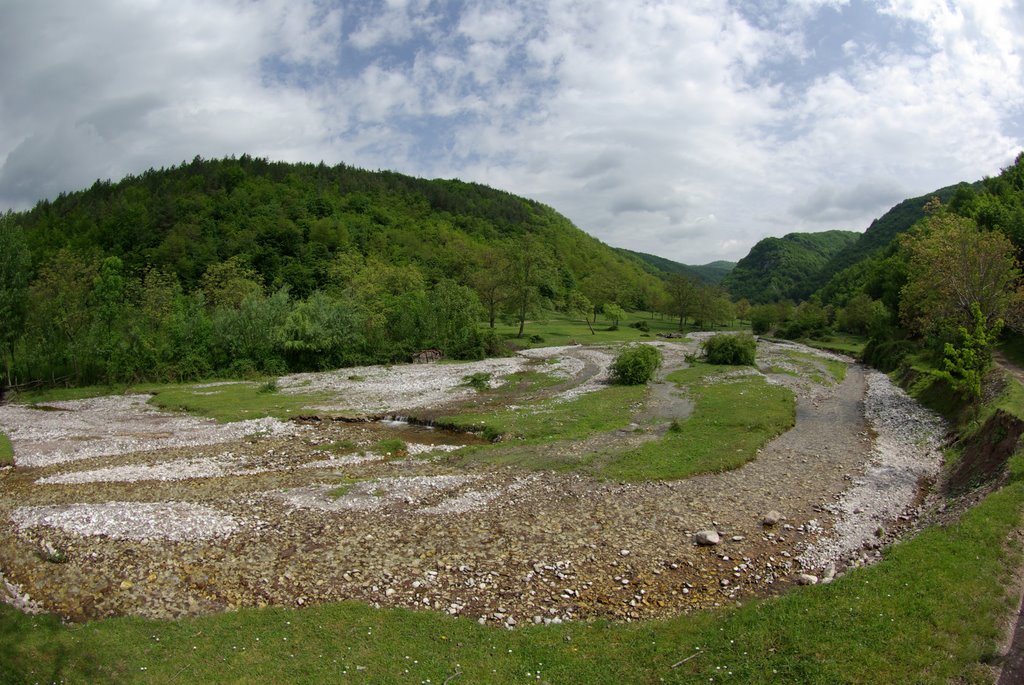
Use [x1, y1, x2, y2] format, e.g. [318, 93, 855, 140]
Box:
[0, 394, 305, 467]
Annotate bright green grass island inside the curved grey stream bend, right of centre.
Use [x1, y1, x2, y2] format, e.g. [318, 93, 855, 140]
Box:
[600, 363, 797, 480]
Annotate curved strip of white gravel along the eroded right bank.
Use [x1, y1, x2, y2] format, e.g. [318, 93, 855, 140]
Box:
[798, 371, 944, 568]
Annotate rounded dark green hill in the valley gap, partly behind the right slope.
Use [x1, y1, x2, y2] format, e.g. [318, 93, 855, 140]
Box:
[722, 230, 860, 303]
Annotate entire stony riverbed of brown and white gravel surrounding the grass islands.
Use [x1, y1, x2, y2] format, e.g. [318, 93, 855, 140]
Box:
[0, 335, 941, 627]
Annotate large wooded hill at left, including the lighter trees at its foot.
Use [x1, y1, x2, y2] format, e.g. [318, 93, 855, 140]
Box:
[0, 156, 666, 385]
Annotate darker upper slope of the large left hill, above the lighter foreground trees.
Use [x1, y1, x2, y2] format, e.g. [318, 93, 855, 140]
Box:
[9, 156, 652, 306]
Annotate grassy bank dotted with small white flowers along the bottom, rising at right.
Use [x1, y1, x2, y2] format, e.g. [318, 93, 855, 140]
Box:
[0, 458, 1024, 684]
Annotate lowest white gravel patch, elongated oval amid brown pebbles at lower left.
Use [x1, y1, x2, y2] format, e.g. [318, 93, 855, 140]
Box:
[10, 502, 240, 541]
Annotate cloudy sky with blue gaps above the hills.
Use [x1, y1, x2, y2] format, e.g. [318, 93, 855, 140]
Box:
[0, 0, 1024, 263]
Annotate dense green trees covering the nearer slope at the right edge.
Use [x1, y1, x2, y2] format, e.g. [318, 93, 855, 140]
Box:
[798, 154, 1024, 401]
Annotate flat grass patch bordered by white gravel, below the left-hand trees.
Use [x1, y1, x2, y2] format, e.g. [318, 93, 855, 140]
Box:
[150, 382, 328, 423]
